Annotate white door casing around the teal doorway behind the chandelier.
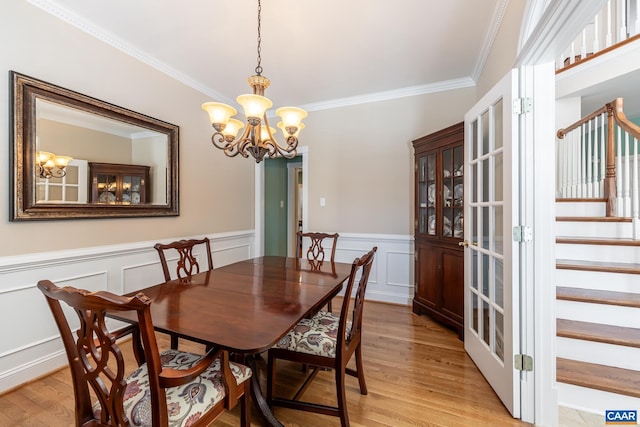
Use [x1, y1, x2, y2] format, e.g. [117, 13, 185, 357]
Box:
[252, 147, 309, 257]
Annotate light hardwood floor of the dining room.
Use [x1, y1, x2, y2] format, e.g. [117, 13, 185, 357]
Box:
[0, 301, 529, 427]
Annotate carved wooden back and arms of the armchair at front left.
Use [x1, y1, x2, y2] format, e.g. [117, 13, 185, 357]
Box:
[38, 280, 248, 427]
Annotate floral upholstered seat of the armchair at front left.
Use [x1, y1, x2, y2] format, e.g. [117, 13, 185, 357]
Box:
[94, 350, 251, 427]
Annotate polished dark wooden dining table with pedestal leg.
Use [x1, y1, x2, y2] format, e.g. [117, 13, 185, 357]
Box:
[110, 256, 351, 426]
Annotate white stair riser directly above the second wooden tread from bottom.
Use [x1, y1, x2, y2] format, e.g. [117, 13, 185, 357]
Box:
[556, 300, 640, 329]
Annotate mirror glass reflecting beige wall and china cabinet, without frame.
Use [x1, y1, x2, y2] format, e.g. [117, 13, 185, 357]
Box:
[36, 99, 168, 205]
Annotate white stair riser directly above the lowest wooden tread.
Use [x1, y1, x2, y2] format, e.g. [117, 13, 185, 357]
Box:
[556, 337, 640, 370]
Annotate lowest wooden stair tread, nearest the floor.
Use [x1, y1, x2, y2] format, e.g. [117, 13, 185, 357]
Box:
[556, 357, 640, 397]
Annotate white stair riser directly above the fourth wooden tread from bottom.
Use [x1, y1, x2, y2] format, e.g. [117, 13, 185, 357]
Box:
[556, 243, 640, 264]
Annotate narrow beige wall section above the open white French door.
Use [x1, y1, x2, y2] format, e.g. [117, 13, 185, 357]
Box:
[476, 1, 526, 99]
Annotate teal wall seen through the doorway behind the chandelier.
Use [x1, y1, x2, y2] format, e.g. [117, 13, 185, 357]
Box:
[264, 158, 288, 256]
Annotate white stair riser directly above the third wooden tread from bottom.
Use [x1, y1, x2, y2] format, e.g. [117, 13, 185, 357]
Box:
[556, 268, 640, 293]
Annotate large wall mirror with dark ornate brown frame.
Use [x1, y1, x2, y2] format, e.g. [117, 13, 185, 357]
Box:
[10, 71, 179, 221]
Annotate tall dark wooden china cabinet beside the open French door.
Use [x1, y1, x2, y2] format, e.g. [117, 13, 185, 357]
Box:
[413, 123, 464, 338]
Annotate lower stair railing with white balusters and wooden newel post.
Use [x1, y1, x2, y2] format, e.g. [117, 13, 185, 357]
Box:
[556, 98, 640, 226]
